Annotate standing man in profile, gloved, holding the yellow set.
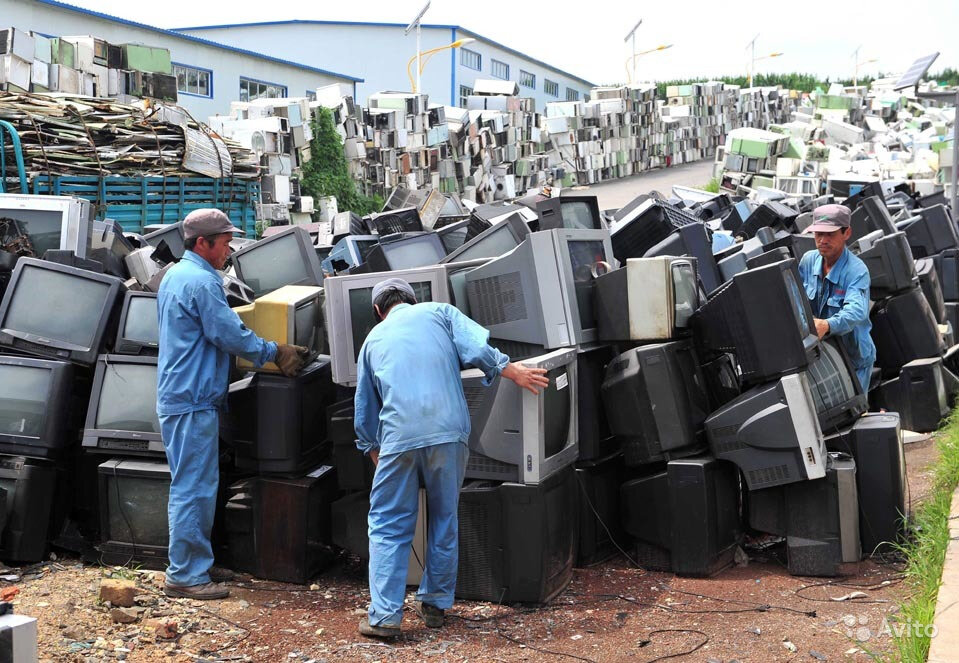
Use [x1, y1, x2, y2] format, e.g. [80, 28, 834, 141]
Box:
[157, 209, 306, 599]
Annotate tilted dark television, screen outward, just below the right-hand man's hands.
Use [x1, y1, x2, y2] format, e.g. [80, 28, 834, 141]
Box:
[806, 337, 869, 431]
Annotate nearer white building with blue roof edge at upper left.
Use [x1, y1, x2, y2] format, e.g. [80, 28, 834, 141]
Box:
[0, 0, 363, 121]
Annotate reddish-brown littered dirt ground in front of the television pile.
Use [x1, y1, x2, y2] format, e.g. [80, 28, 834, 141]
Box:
[7, 440, 936, 663]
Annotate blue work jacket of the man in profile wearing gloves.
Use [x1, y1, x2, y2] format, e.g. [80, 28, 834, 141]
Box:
[157, 251, 276, 416]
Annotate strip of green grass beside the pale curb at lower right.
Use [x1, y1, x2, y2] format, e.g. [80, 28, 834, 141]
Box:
[890, 410, 959, 663]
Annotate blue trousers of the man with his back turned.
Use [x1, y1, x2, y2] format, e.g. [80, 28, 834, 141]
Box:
[369, 442, 469, 626]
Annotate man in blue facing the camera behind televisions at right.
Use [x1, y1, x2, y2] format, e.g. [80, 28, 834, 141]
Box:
[799, 205, 876, 392]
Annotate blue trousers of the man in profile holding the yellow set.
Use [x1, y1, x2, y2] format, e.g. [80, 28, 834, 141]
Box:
[160, 410, 220, 586]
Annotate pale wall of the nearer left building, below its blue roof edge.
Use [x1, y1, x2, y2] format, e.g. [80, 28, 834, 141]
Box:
[0, 0, 352, 121]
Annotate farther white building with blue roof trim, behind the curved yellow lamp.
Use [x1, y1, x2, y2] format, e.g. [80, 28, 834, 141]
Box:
[177, 21, 593, 111]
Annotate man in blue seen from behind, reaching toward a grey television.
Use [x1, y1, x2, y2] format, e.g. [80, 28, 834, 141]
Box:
[354, 278, 549, 637]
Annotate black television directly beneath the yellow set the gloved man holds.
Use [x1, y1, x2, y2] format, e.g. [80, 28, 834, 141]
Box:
[220, 355, 336, 475]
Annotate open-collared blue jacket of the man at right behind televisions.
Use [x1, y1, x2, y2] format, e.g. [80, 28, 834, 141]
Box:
[799, 248, 876, 391]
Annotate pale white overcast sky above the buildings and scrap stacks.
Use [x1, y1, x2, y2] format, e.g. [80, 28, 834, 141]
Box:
[67, 0, 959, 84]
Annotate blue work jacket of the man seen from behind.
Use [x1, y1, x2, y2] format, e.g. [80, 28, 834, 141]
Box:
[353, 302, 509, 456]
